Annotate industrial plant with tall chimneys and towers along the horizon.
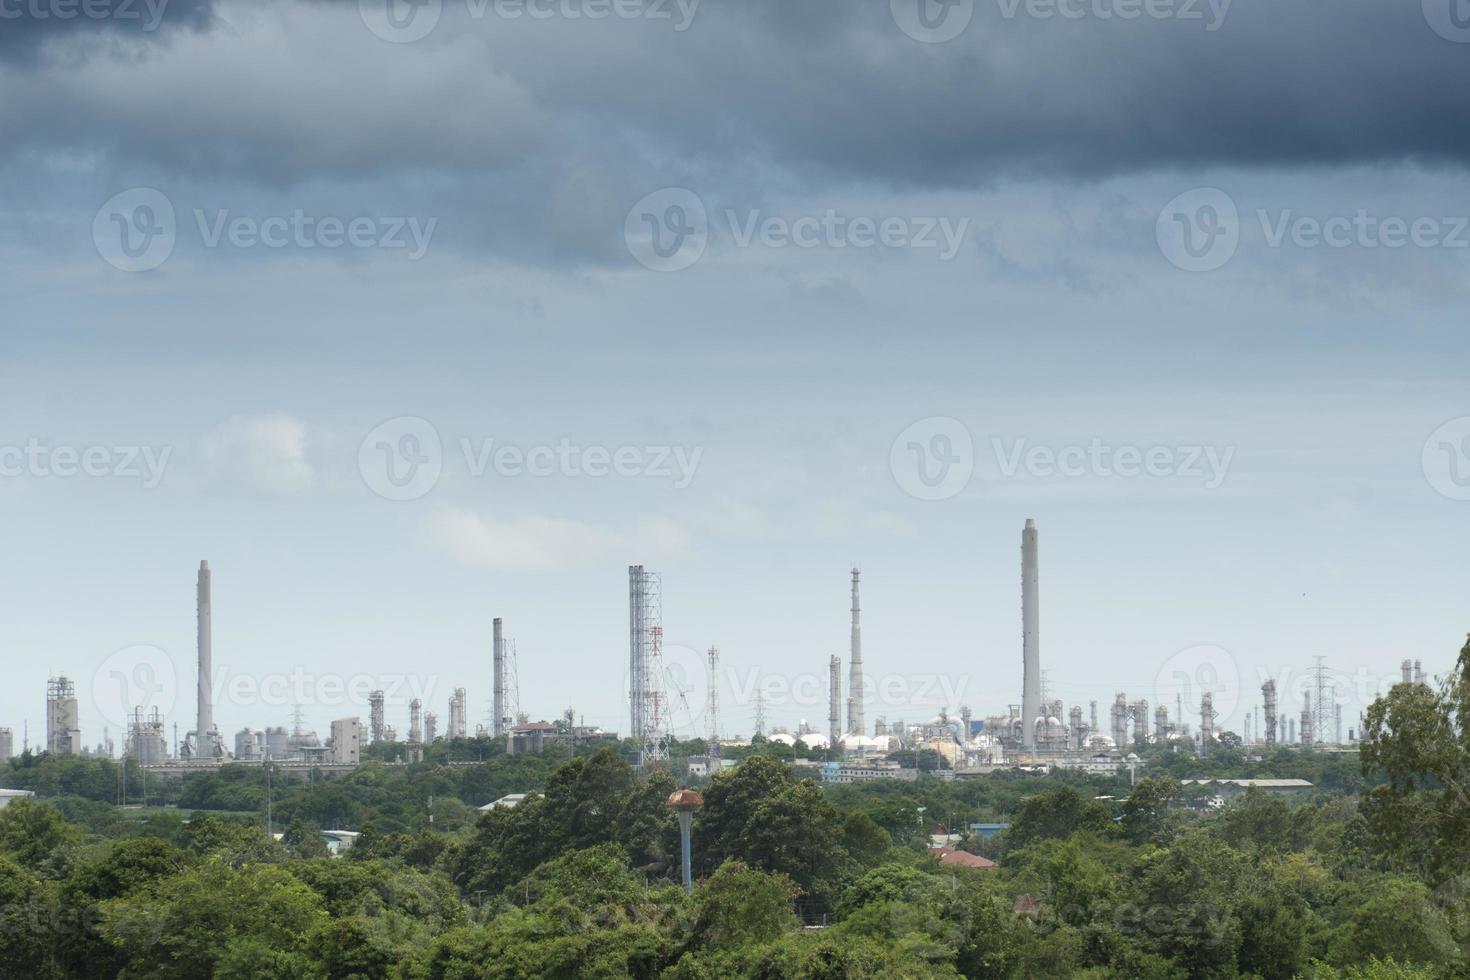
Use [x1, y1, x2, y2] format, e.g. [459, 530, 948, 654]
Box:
[0, 520, 1426, 782]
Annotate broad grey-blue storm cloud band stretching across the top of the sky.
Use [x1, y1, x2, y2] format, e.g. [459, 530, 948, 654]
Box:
[0, 0, 1470, 188]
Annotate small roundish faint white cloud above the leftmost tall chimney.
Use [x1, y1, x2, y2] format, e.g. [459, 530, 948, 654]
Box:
[204, 411, 315, 495]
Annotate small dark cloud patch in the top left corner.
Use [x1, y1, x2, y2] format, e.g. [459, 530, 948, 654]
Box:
[0, 0, 215, 60]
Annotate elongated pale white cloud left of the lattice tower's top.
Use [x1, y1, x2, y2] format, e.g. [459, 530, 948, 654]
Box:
[428, 508, 689, 572]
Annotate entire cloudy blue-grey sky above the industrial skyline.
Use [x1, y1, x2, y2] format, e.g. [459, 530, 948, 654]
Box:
[0, 0, 1470, 749]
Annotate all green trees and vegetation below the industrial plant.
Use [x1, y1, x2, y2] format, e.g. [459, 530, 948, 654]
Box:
[0, 644, 1470, 980]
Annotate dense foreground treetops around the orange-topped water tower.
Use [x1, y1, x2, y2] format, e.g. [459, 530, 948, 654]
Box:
[0, 751, 1470, 980]
